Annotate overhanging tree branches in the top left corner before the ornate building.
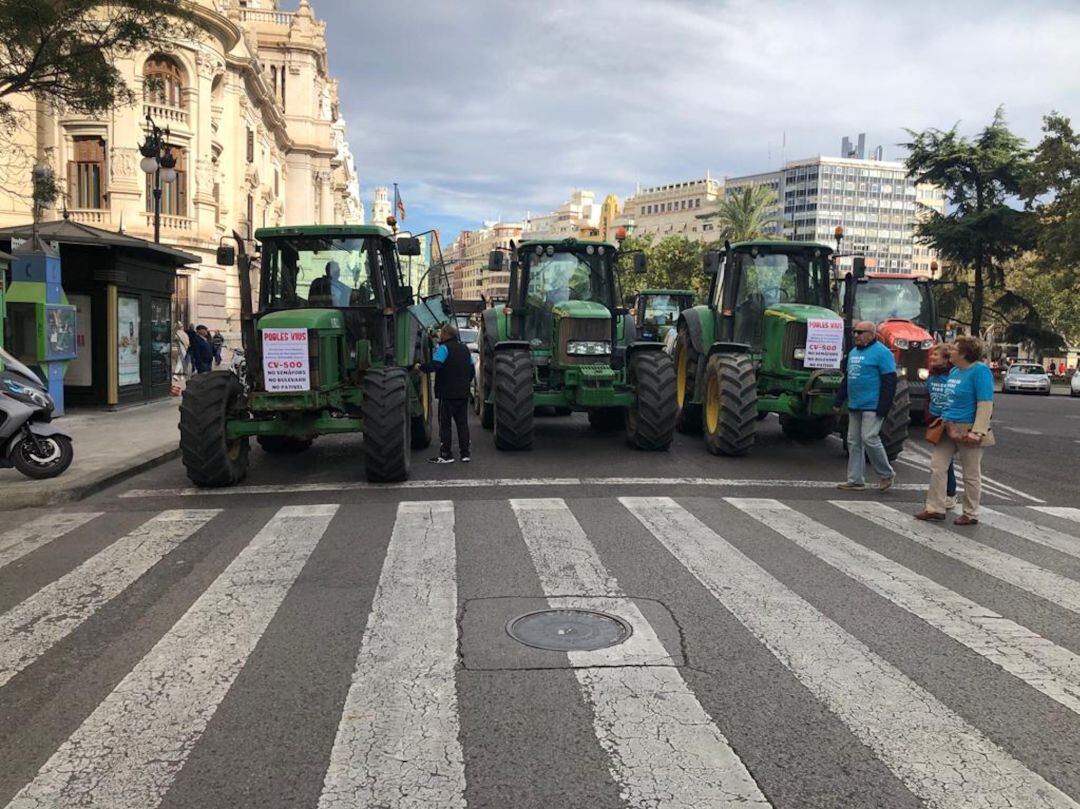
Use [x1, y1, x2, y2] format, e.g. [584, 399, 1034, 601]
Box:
[0, 0, 191, 131]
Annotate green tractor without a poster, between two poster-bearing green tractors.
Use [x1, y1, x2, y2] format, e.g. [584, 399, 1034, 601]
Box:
[477, 239, 675, 449]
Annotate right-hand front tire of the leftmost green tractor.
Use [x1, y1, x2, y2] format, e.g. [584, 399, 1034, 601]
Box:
[361, 368, 413, 483]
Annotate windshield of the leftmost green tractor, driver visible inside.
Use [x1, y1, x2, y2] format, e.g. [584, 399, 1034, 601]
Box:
[261, 237, 389, 309]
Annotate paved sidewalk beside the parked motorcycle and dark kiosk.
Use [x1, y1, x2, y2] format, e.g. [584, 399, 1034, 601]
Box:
[0, 396, 180, 511]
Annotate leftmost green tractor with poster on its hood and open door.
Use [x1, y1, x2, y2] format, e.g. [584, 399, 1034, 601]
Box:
[180, 225, 450, 486]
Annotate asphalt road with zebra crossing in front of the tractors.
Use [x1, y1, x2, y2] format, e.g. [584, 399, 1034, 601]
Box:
[0, 396, 1080, 809]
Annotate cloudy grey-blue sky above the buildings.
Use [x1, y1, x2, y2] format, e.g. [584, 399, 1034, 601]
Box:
[308, 0, 1080, 240]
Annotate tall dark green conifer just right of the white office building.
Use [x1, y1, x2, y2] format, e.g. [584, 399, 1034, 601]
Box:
[904, 107, 1035, 334]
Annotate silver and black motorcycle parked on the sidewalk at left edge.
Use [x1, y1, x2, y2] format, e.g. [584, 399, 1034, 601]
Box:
[0, 348, 75, 478]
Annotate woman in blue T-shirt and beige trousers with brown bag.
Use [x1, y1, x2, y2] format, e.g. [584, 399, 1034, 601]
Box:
[915, 336, 995, 525]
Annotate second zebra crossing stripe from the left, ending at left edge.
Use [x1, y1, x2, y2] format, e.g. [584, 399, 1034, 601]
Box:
[0, 509, 219, 686]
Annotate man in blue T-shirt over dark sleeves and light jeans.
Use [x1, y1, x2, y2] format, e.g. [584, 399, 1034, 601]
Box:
[834, 320, 896, 491]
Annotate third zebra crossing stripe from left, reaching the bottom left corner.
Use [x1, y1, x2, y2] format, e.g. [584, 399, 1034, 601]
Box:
[8, 505, 338, 809]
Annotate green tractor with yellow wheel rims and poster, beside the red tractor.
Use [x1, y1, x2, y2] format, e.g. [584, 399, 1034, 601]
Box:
[674, 241, 908, 458]
